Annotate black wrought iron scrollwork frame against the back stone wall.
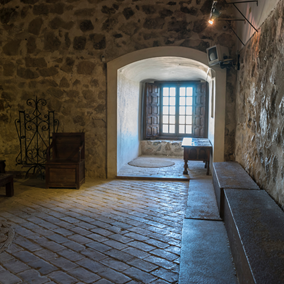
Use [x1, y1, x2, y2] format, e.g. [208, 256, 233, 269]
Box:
[15, 97, 59, 177]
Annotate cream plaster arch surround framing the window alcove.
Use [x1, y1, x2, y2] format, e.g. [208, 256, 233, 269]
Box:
[107, 46, 226, 178]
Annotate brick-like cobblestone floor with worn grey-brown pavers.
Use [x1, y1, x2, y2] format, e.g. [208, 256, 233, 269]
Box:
[0, 180, 188, 284]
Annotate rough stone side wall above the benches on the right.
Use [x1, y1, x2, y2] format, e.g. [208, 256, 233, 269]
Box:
[235, 0, 284, 207]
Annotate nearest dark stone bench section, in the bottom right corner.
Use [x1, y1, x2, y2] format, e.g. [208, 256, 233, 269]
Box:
[224, 189, 284, 284]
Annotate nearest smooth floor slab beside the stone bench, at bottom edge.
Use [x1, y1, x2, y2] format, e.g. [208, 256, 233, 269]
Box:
[179, 219, 238, 284]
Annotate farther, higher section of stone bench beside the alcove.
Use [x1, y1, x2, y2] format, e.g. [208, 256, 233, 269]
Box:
[212, 162, 259, 219]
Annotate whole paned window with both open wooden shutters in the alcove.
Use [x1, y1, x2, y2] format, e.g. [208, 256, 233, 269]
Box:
[144, 82, 208, 139]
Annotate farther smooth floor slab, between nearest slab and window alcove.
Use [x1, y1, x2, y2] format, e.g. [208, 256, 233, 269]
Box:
[185, 177, 221, 221]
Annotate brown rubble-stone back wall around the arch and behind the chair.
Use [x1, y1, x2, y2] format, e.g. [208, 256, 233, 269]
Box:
[0, 0, 235, 177]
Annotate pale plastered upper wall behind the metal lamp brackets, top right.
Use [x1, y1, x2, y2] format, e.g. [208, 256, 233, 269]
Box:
[227, 0, 279, 50]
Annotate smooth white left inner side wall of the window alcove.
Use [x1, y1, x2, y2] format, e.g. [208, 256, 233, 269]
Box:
[117, 70, 140, 171]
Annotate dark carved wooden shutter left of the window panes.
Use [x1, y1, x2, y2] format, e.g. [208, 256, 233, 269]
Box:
[144, 83, 160, 139]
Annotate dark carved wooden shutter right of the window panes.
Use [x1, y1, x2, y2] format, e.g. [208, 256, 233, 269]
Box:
[193, 82, 208, 138]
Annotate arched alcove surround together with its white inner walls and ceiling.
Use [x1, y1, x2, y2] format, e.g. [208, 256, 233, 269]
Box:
[107, 47, 226, 178]
